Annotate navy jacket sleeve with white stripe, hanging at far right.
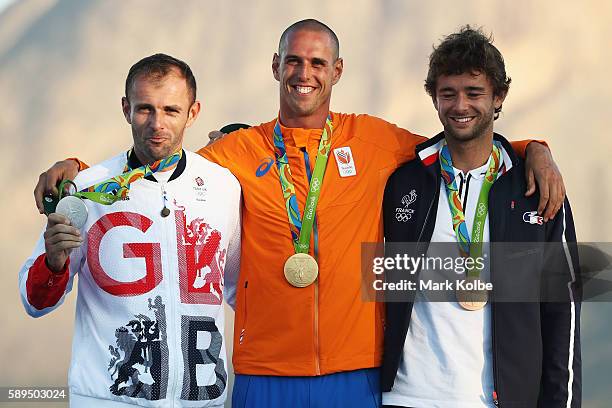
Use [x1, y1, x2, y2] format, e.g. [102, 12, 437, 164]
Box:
[539, 199, 582, 408]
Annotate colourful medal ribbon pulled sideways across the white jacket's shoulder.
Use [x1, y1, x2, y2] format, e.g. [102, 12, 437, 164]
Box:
[59, 149, 183, 205]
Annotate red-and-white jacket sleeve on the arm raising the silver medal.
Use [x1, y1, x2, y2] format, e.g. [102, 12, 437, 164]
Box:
[19, 225, 82, 317]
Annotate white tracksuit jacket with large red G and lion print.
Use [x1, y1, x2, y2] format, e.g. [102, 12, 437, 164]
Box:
[19, 152, 240, 408]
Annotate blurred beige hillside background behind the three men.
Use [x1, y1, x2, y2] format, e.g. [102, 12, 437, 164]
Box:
[0, 0, 612, 408]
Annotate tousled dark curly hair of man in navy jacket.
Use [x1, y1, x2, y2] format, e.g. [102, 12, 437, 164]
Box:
[425, 25, 511, 119]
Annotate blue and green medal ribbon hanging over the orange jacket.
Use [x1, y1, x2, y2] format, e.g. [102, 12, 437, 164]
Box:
[274, 115, 334, 253]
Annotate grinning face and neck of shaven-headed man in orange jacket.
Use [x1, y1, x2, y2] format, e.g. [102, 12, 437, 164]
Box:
[272, 29, 343, 127]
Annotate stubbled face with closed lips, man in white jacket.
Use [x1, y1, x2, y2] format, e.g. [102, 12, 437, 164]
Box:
[122, 70, 200, 164]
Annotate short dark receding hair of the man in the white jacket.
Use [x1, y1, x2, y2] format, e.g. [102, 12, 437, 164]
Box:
[125, 54, 197, 103]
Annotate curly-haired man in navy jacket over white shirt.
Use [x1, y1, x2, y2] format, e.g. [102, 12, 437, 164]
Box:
[382, 26, 581, 408]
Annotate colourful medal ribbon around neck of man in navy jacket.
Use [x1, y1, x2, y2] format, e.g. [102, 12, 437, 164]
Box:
[439, 141, 501, 278]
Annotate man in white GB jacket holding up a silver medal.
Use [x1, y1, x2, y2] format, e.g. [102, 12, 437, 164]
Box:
[19, 54, 240, 407]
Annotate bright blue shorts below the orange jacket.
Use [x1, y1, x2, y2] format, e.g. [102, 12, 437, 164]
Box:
[232, 368, 381, 408]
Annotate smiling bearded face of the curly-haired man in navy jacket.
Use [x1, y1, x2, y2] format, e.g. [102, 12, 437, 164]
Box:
[434, 72, 505, 142]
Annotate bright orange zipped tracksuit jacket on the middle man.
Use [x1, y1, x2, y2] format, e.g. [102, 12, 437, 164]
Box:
[198, 113, 528, 376]
